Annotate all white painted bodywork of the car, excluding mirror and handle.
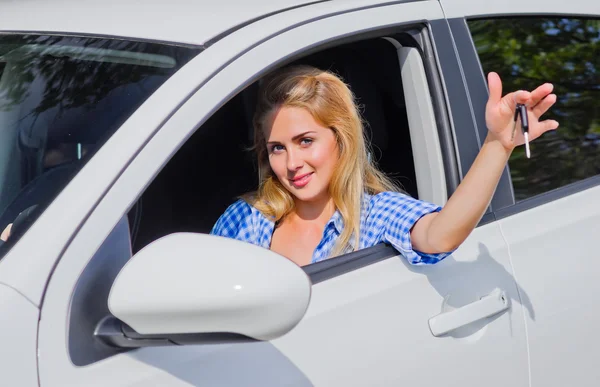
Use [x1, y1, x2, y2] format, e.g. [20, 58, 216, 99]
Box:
[0, 0, 600, 386]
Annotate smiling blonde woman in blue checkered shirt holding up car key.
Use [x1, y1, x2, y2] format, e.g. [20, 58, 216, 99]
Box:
[211, 66, 558, 266]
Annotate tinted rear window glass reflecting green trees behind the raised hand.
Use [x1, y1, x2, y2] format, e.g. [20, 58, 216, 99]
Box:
[468, 17, 600, 201]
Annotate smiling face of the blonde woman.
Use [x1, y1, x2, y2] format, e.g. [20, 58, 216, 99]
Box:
[265, 107, 339, 202]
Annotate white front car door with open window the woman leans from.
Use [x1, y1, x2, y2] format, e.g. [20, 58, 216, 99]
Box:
[38, 1, 528, 386]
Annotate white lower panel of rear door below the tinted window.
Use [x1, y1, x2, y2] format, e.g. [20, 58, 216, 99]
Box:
[500, 187, 600, 387]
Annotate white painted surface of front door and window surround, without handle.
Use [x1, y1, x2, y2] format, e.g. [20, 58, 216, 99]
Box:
[35, 3, 528, 386]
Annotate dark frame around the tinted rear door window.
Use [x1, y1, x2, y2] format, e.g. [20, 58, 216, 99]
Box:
[448, 13, 600, 220]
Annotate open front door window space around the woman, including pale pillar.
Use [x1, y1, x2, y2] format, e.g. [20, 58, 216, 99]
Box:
[129, 34, 446, 253]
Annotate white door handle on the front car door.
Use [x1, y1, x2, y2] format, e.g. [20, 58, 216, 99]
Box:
[429, 289, 509, 337]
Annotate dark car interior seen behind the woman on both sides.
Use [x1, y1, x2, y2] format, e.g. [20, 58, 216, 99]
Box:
[129, 38, 418, 253]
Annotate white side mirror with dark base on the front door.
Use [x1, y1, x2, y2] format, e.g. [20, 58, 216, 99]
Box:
[96, 233, 311, 347]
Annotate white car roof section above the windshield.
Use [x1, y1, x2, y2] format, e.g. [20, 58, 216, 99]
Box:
[0, 0, 324, 45]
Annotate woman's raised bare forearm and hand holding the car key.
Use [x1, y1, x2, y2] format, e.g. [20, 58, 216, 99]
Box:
[411, 73, 558, 253]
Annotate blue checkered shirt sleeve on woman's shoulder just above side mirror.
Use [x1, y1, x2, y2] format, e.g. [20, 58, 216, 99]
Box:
[210, 200, 256, 243]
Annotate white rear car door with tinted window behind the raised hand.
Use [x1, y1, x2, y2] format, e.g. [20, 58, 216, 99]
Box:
[442, 0, 600, 386]
